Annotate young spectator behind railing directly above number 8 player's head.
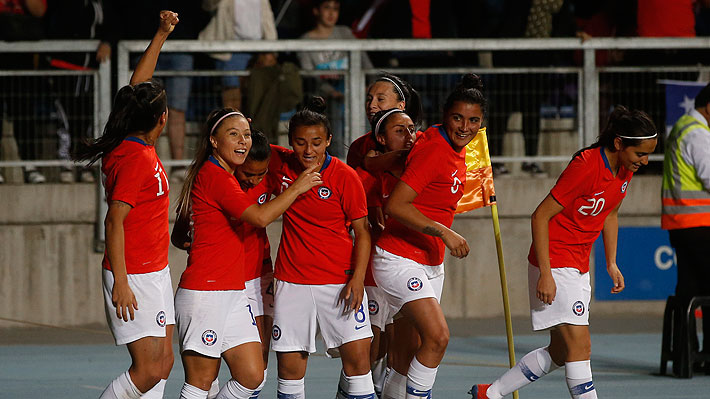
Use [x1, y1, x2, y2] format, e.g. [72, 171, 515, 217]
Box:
[298, 0, 372, 158]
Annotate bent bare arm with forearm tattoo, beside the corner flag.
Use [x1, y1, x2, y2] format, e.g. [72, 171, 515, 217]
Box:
[385, 181, 469, 258]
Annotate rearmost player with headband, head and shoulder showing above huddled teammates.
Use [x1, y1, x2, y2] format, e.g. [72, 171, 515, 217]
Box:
[347, 73, 422, 172]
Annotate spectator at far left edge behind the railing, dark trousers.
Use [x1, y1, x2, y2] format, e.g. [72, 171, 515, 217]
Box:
[0, 0, 47, 184]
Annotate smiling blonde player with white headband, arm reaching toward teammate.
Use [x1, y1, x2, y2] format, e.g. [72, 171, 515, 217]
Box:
[175, 108, 321, 399]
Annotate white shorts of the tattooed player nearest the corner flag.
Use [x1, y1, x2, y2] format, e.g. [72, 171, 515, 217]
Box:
[372, 246, 444, 313]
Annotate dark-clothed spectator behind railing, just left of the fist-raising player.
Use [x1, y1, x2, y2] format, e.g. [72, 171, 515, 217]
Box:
[45, 0, 111, 183]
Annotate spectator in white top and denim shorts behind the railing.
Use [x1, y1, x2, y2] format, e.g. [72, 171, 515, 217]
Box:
[199, 0, 277, 110]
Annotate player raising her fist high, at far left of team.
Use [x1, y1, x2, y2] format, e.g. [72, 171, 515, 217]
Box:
[74, 11, 178, 399]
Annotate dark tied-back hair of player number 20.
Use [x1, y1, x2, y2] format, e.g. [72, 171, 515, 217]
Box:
[572, 105, 658, 159]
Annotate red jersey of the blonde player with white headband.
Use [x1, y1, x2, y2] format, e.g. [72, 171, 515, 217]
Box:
[180, 156, 254, 291]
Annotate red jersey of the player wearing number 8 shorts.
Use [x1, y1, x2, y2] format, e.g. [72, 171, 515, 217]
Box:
[269, 147, 367, 285]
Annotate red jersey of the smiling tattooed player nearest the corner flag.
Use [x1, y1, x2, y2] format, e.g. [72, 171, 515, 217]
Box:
[377, 125, 466, 266]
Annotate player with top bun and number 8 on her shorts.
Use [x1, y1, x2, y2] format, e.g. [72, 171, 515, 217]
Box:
[270, 97, 374, 399]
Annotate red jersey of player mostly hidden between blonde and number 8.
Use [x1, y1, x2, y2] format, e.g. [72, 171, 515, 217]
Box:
[240, 175, 275, 281]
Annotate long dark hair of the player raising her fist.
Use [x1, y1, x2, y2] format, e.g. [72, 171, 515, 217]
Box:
[72, 80, 168, 165]
